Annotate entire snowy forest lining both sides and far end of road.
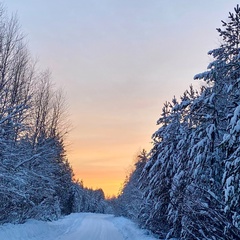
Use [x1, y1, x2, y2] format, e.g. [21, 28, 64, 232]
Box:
[0, 3, 240, 240]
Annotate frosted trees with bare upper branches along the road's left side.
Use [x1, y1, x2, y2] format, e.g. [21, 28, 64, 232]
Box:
[0, 6, 109, 223]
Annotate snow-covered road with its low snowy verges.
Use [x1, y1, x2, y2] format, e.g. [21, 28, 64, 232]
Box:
[0, 213, 158, 240]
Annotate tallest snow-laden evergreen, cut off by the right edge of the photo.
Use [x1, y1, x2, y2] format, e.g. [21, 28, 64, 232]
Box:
[195, 5, 240, 239]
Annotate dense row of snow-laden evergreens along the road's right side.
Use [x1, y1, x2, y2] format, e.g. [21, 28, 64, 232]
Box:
[113, 6, 240, 240]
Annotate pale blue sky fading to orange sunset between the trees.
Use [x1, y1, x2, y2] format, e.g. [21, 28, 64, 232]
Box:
[3, 0, 239, 196]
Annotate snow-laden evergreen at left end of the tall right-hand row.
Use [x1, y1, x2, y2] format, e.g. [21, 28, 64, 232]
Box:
[139, 102, 175, 237]
